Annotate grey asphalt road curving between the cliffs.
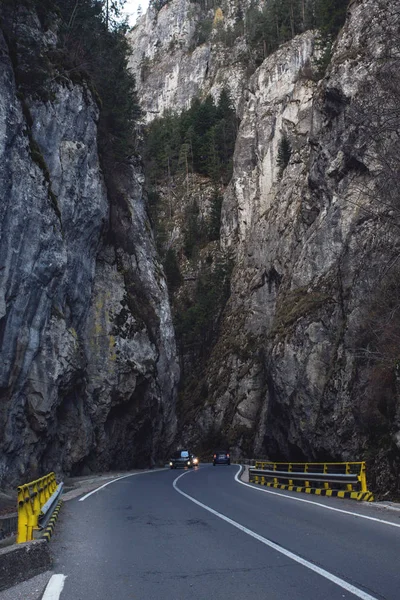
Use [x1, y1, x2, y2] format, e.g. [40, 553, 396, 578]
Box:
[51, 465, 400, 600]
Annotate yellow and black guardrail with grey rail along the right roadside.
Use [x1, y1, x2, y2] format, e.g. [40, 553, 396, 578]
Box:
[249, 460, 374, 502]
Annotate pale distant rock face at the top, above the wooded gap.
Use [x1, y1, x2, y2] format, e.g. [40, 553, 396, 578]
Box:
[128, 0, 250, 122]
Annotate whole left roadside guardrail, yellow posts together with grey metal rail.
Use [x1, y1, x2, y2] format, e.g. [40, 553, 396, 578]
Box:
[17, 473, 63, 544]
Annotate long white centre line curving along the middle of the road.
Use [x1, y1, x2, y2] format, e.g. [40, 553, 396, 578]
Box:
[172, 472, 378, 600]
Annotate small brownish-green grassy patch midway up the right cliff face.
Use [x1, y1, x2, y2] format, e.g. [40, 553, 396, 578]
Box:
[270, 287, 333, 337]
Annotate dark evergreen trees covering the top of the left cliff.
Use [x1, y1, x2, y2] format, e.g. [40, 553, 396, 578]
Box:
[1, 0, 140, 179]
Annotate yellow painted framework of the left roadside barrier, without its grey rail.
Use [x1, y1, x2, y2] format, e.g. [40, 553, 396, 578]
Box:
[17, 473, 57, 544]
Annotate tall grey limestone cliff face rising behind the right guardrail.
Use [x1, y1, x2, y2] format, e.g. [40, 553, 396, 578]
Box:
[197, 2, 399, 474]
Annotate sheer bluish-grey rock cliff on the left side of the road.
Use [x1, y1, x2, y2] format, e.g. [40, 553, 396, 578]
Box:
[0, 2, 179, 484]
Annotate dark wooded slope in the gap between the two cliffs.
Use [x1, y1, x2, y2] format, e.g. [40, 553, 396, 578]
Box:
[144, 90, 237, 310]
